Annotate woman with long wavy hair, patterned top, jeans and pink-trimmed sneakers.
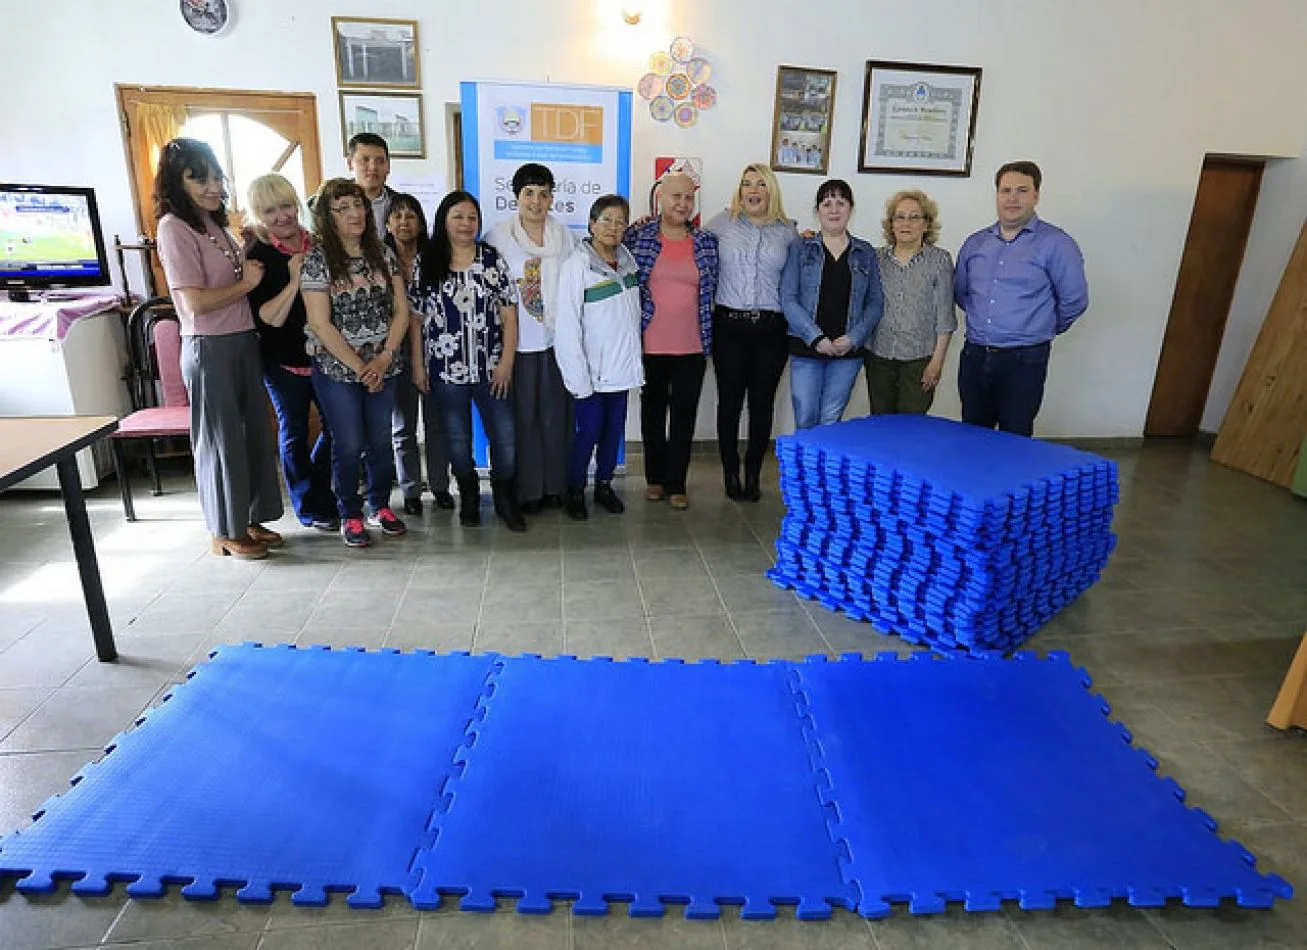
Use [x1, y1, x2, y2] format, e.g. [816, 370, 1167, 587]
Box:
[299, 178, 409, 548]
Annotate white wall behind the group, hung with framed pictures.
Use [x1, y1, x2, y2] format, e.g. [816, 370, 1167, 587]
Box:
[0, 0, 1307, 435]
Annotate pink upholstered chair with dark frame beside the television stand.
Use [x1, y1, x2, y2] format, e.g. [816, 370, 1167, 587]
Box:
[110, 297, 191, 521]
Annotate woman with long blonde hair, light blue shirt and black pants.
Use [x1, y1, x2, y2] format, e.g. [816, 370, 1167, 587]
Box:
[706, 163, 799, 502]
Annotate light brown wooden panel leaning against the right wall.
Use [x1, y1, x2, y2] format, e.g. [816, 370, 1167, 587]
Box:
[1212, 218, 1307, 486]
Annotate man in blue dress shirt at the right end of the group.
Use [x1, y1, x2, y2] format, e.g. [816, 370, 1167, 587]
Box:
[953, 162, 1089, 435]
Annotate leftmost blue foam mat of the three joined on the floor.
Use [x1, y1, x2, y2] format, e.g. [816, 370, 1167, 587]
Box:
[0, 647, 494, 907]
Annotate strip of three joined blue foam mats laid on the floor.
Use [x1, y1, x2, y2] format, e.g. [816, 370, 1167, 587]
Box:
[0, 644, 1291, 917]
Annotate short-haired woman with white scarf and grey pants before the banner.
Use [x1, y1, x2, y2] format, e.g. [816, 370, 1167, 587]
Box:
[485, 162, 576, 515]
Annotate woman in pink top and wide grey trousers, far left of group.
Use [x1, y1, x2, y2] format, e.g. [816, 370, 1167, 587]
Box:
[154, 139, 282, 559]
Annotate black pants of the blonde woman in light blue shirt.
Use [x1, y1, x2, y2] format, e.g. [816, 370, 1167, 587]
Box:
[712, 307, 789, 480]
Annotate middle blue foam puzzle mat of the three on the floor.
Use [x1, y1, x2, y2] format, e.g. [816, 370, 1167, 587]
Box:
[413, 659, 852, 919]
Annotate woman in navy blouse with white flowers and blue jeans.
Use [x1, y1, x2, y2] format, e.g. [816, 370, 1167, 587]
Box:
[409, 191, 527, 531]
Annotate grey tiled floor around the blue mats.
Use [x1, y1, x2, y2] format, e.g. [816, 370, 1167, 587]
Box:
[0, 444, 1307, 950]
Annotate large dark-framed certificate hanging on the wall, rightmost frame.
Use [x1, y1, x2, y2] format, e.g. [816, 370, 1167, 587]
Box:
[857, 60, 980, 176]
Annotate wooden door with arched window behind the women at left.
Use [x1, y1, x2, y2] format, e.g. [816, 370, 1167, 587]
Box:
[116, 85, 323, 289]
